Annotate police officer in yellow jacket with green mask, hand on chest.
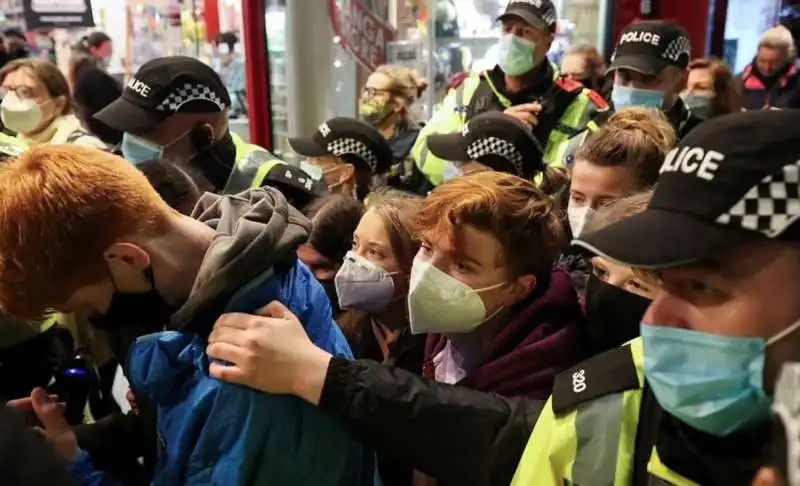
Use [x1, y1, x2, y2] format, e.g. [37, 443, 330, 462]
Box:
[411, 0, 608, 185]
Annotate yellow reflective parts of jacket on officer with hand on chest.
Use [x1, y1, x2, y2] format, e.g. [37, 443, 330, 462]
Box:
[411, 65, 599, 186]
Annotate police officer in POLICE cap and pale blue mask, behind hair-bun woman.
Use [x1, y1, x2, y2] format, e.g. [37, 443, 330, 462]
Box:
[564, 20, 703, 165]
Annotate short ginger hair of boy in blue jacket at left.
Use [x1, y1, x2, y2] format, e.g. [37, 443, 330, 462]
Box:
[0, 145, 175, 318]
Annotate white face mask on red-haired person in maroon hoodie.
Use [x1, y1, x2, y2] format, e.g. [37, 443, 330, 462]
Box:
[408, 261, 505, 334]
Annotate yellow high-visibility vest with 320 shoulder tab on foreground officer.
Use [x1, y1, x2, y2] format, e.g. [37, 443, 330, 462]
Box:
[511, 338, 699, 486]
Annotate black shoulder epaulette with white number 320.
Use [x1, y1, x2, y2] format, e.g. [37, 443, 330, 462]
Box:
[552, 345, 639, 415]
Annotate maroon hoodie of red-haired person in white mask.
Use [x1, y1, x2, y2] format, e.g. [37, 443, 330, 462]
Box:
[423, 269, 584, 400]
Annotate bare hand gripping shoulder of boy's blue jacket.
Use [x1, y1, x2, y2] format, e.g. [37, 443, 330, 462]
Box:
[207, 301, 331, 404]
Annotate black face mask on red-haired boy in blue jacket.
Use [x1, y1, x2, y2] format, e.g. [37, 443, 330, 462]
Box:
[89, 268, 174, 373]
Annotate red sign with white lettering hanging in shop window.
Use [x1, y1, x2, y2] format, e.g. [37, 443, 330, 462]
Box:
[329, 0, 395, 71]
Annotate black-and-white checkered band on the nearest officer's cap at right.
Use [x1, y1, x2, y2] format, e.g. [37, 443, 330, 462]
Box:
[717, 161, 800, 238]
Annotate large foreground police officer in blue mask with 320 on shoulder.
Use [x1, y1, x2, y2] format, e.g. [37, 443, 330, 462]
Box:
[512, 111, 800, 486]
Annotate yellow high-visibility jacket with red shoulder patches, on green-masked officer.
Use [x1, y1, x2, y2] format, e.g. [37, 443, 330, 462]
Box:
[411, 68, 608, 186]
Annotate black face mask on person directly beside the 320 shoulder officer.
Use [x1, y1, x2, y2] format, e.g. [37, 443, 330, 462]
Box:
[586, 273, 651, 355]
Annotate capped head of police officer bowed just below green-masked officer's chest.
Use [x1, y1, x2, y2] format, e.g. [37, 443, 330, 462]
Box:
[427, 112, 545, 182]
